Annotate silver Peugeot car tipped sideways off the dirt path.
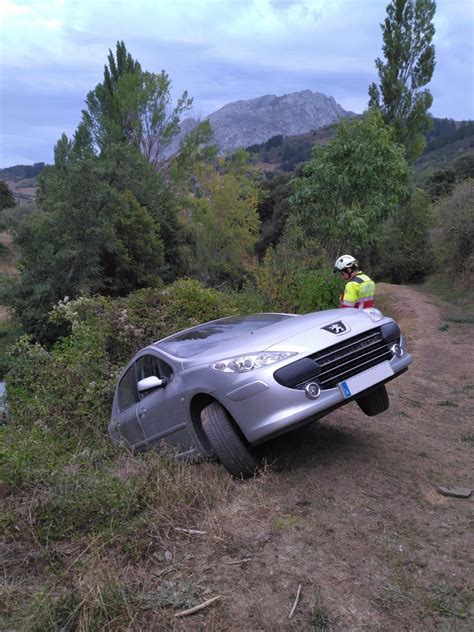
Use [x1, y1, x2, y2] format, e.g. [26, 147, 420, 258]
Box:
[109, 308, 412, 477]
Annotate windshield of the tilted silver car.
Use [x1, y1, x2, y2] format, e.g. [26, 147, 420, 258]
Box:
[157, 314, 293, 358]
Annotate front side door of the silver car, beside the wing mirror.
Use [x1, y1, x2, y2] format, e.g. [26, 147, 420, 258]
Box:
[136, 353, 187, 446]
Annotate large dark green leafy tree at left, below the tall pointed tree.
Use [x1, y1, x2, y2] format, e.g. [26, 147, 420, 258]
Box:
[2, 141, 166, 341]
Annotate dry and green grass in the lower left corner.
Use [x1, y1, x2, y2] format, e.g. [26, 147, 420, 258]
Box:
[0, 414, 237, 632]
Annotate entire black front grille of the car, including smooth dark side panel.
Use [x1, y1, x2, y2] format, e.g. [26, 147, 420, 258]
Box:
[274, 325, 400, 389]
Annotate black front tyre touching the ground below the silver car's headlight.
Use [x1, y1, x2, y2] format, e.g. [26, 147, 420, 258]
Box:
[201, 402, 258, 478]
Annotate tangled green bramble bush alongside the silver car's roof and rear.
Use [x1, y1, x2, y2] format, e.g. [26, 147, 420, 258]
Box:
[5, 280, 241, 486]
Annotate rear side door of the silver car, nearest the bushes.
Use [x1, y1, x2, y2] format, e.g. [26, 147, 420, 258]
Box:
[112, 363, 145, 446]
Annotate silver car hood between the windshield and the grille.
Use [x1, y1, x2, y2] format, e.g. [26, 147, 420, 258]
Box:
[180, 309, 391, 368]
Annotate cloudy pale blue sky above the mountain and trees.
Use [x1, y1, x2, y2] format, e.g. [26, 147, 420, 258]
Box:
[0, 0, 474, 168]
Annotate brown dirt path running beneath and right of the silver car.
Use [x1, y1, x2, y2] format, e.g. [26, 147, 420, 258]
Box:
[176, 284, 474, 632]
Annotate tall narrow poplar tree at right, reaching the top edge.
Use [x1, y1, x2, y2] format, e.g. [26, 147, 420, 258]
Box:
[369, 0, 436, 162]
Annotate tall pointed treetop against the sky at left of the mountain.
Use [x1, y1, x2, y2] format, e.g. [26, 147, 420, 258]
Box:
[81, 41, 192, 166]
